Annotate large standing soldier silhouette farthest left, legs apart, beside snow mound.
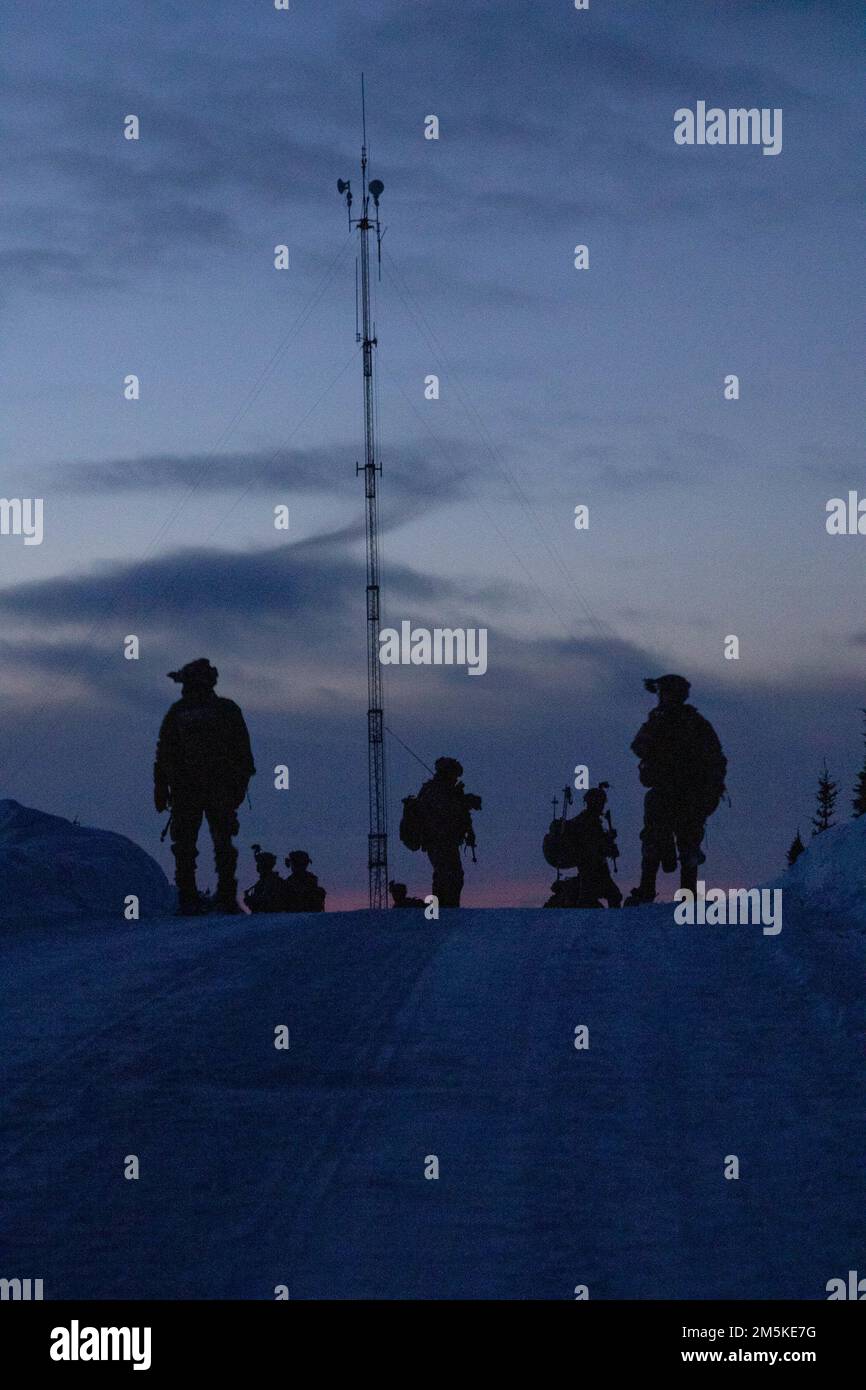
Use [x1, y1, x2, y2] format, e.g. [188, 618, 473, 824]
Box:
[153, 657, 256, 916]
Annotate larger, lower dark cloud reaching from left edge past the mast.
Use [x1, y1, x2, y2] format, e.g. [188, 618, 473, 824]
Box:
[0, 525, 520, 705]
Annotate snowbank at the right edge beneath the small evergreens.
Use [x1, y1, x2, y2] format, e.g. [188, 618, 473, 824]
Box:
[774, 816, 866, 917]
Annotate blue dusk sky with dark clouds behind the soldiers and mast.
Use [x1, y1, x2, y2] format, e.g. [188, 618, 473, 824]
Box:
[0, 0, 866, 906]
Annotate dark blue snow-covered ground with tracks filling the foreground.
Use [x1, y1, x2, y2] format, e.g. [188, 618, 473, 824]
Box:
[0, 827, 866, 1300]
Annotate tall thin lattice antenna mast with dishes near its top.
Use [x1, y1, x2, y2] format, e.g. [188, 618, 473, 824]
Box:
[336, 74, 388, 908]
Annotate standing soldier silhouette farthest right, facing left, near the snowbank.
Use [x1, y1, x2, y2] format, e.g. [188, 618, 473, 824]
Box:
[626, 676, 727, 908]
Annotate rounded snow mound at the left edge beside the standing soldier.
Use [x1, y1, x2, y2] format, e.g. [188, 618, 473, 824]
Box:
[0, 801, 174, 919]
